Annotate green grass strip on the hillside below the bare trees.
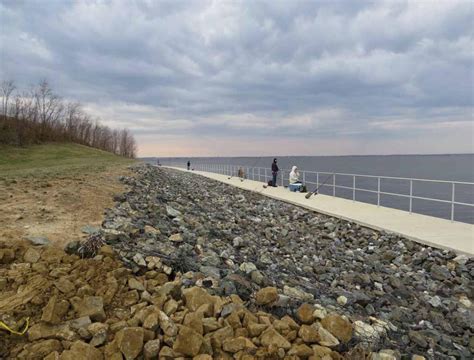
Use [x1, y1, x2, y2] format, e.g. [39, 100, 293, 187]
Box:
[0, 143, 135, 179]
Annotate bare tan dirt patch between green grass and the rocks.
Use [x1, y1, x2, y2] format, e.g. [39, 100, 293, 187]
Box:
[0, 165, 128, 247]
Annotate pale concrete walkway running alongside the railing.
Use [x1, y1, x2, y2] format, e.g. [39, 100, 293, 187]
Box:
[166, 168, 474, 256]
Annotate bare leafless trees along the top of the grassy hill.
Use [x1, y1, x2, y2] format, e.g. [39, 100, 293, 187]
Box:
[0, 80, 136, 158]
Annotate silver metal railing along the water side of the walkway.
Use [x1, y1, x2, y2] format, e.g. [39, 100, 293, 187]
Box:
[170, 163, 474, 221]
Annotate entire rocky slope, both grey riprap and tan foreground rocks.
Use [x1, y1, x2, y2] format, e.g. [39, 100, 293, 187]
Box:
[0, 166, 474, 360]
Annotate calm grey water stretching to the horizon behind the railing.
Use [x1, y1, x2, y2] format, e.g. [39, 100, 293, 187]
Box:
[146, 154, 474, 224]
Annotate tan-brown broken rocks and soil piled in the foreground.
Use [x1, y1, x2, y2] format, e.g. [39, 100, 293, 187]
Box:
[0, 243, 396, 360]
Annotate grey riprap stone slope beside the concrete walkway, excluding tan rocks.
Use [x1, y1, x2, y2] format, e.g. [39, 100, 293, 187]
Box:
[93, 166, 474, 359]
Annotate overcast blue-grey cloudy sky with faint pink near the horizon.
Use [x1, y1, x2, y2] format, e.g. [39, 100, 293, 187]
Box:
[0, 0, 474, 156]
